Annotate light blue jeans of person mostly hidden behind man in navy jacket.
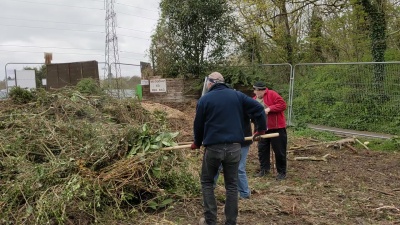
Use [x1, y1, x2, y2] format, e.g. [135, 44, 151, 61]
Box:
[214, 145, 250, 198]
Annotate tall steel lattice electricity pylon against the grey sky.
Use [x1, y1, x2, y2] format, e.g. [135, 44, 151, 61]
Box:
[104, 0, 121, 94]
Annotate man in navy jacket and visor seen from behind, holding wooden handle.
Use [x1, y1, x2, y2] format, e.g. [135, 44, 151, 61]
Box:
[191, 72, 266, 225]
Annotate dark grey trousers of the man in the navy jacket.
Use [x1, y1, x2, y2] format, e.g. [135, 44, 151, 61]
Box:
[201, 143, 240, 225]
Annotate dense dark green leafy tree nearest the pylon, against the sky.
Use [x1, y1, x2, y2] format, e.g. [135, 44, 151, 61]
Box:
[150, 0, 232, 77]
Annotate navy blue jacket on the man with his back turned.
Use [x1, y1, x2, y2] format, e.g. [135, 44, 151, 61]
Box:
[193, 83, 266, 146]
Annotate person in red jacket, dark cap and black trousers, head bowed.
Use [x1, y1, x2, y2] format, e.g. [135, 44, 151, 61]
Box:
[253, 81, 287, 180]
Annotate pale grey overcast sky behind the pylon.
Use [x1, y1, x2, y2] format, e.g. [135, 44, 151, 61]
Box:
[0, 0, 160, 80]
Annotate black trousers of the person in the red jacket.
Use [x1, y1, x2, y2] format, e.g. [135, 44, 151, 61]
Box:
[258, 128, 287, 174]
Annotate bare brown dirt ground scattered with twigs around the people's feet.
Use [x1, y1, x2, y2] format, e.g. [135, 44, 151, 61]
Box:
[142, 102, 400, 225]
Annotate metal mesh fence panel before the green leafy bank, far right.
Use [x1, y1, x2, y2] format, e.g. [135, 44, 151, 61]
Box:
[292, 62, 400, 135]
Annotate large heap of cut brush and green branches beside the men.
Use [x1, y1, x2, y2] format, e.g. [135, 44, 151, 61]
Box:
[0, 80, 199, 224]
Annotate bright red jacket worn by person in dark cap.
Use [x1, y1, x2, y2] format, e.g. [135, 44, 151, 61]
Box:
[253, 89, 286, 130]
